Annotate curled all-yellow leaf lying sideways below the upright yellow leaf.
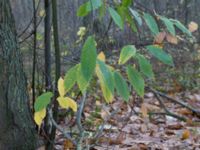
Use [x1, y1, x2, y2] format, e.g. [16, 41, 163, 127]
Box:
[57, 97, 77, 112]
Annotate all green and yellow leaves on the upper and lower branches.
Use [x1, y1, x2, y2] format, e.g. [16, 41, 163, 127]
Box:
[34, 0, 194, 126]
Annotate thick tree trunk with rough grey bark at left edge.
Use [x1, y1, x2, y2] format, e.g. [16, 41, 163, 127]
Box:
[0, 0, 36, 150]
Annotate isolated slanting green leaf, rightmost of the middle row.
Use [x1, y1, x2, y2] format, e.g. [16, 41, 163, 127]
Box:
[146, 45, 174, 66]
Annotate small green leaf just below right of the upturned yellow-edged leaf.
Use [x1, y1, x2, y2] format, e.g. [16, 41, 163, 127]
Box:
[137, 55, 154, 78]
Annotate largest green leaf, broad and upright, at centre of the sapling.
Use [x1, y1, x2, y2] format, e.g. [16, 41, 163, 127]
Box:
[81, 36, 97, 82]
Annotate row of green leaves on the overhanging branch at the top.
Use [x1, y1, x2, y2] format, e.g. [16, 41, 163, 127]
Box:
[77, 0, 192, 36]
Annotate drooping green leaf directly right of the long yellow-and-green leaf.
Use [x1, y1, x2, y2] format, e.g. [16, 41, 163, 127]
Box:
[114, 72, 130, 102]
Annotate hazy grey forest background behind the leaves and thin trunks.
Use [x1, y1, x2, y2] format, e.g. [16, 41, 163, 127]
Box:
[11, 0, 200, 88]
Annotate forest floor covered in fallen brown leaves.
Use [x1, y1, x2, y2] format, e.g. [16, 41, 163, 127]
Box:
[55, 91, 200, 150]
